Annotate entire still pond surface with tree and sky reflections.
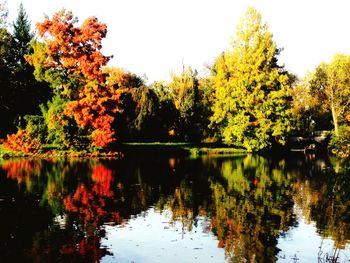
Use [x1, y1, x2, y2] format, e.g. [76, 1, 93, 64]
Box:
[0, 153, 350, 262]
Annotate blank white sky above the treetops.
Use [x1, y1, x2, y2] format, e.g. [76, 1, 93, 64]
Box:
[5, 0, 350, 82]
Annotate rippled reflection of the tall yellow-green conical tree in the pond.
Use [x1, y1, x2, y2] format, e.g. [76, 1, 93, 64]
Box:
[211, 155, 293, 262]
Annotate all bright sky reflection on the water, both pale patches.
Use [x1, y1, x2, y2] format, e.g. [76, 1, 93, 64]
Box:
[101, 208, 350, 263]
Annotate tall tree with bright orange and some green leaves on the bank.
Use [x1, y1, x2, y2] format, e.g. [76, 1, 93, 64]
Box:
[26, 10, 119, 147]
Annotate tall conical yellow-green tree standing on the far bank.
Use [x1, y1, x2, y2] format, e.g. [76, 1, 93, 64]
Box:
[211, 8, 291, 151]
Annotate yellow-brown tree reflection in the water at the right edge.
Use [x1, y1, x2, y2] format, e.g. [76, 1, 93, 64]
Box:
[294, 166, 350, 249]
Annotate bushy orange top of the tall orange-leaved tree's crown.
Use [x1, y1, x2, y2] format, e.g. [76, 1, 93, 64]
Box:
[37, 10, 109, 82]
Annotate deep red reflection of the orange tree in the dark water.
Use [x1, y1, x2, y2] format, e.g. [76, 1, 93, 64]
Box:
[59, 164, 122, 262]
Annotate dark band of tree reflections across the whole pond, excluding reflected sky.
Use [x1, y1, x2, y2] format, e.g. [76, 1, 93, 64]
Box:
[0, 155, 350, 262]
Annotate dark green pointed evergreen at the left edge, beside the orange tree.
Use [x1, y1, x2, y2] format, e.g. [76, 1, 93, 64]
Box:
[0, 4, 52, 137]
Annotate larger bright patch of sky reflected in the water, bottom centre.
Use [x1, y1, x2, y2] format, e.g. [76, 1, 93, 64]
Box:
[101, 208, 225, 263]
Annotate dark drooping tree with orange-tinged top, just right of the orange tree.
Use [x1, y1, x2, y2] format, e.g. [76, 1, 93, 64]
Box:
[104, 67, 169, 141]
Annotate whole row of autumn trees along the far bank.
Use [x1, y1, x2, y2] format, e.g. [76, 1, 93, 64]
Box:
[0, 6, 350, 155]
